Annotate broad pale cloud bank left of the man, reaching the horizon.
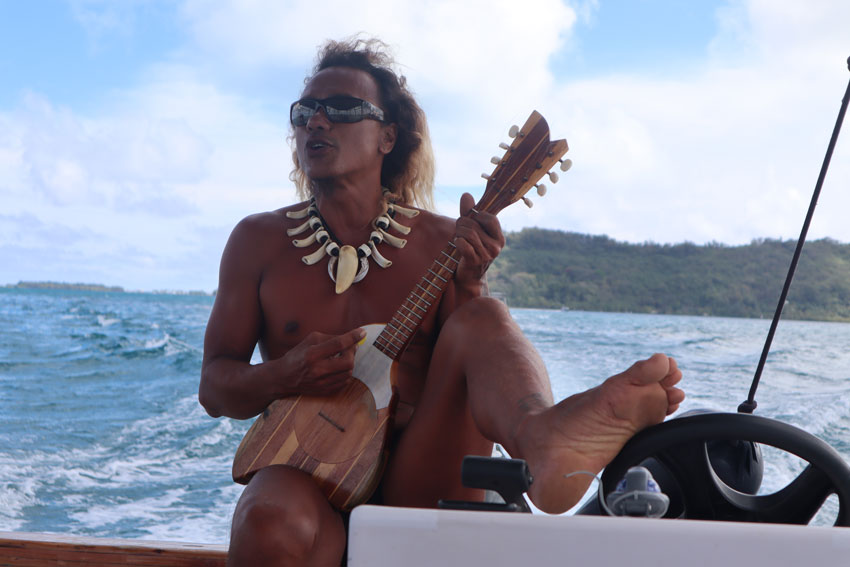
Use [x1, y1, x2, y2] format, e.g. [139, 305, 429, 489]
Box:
[0, 73, 293, 290]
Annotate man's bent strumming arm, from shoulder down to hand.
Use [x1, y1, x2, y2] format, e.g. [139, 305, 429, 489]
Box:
[198, 216, 365, 419]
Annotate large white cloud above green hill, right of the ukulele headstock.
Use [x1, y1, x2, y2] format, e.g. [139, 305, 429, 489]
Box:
[496, 2, 850, 243]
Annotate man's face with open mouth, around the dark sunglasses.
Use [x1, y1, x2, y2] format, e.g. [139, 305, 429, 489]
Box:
[295, 67, 392, 187]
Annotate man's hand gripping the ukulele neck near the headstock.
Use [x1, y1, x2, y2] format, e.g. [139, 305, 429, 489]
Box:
[454, 193, 505, 289]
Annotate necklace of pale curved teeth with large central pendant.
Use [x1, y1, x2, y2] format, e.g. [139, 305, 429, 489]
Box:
[286, 197, 419, 294]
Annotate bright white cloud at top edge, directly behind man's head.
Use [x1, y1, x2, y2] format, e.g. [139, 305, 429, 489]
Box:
[177, 0, 576, 185]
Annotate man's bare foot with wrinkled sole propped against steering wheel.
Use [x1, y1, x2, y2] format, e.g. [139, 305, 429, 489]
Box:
[515, 354, 685, 514]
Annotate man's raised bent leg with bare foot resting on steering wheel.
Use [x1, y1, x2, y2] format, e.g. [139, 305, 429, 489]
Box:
[385, 298, 684, 513]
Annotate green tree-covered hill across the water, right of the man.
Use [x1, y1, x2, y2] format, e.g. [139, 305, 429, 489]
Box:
[488, 228, 850, 321]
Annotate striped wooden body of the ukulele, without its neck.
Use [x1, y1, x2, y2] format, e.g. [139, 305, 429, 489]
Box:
[233, 325, 396, 510]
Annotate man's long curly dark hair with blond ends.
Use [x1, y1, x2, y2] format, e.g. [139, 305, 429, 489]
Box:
[289, 38, 434, 209]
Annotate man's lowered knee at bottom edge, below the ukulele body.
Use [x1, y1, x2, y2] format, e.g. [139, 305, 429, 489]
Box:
[227, 466, 346, 567]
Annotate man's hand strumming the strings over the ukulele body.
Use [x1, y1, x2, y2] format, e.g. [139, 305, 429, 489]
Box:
[279, 328, 366, 396]
